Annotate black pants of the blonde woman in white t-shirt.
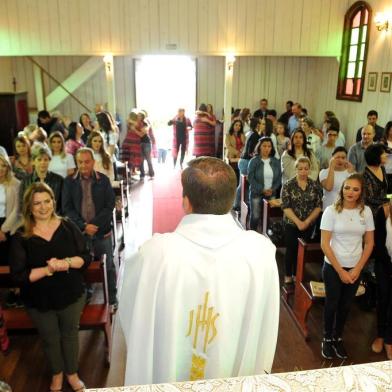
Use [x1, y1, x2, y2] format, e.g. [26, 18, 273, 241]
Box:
[322, 262, 359, 339]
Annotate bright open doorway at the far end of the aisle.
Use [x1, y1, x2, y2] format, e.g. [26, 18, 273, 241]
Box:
[135, 55, 196, 167]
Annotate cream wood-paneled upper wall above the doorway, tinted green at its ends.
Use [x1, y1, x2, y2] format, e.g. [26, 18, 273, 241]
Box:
[0, 0, 348, 56]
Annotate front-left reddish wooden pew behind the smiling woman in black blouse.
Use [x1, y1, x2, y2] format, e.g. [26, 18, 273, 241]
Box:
[0, 256, 112, 366]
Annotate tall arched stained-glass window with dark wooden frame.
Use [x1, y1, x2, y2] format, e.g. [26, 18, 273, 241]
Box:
[336, 1, 372, 102]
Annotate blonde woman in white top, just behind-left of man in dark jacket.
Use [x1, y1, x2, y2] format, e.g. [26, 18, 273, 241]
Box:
[49, 131, 76, 178]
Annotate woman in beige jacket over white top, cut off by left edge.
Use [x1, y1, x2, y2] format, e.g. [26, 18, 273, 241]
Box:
[0, 154, 22, 265]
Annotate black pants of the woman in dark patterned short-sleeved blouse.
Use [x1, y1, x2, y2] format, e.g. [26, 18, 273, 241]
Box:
[284, 223, 314, 276]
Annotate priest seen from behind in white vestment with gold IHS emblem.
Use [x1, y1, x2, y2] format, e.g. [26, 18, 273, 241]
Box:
[119, 157, 279, 385]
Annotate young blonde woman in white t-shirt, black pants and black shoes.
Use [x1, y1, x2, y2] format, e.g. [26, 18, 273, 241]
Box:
[320, 173, 374, 359]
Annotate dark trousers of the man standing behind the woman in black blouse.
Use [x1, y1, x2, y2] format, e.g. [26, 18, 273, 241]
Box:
[87, 235, 117, 305]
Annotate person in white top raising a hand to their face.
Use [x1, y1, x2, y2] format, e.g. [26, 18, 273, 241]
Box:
[319, 147, 355, 211]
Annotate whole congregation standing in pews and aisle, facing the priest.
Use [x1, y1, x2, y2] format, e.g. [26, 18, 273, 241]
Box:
[0, 99, 392, 391]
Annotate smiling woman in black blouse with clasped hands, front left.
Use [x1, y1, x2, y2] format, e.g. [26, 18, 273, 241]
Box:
[10, 182, 90, 392]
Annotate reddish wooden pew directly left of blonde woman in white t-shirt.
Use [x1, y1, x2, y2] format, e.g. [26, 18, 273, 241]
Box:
[284, 238, 324, 340]
